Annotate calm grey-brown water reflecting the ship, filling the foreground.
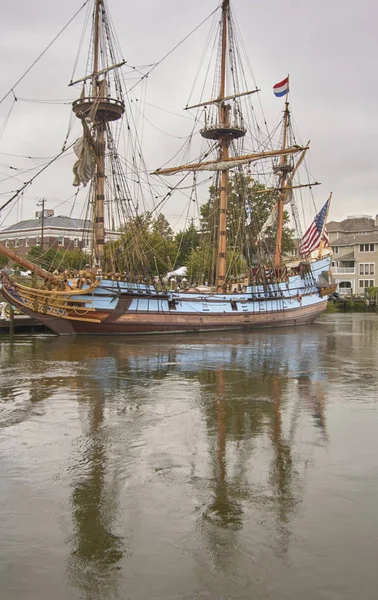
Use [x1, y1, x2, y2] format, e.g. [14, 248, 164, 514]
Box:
[0, 314, 378, 600]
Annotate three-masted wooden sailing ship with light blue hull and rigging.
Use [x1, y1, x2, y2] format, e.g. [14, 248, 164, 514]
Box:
[0, 0, 335, 335]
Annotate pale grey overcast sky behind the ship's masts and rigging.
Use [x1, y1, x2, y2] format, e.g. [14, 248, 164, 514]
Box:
[0, 0, 378, 226]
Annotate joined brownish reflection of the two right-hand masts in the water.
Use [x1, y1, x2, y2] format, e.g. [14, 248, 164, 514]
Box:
[188, 337, 327, 569]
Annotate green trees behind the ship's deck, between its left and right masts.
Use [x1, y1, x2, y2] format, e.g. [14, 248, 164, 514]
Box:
[99, 174, 294, 283]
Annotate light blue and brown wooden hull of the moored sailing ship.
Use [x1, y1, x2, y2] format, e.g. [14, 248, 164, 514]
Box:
[2, 257, 333, 335]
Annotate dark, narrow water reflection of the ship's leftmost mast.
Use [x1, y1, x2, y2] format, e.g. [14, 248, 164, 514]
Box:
[67, 380, 125, 600]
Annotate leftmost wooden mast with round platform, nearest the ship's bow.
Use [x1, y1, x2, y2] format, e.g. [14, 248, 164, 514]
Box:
[72, 0, 125, 267]
